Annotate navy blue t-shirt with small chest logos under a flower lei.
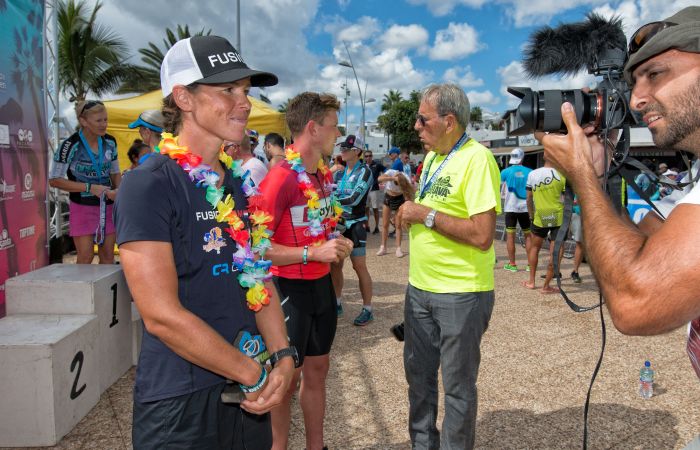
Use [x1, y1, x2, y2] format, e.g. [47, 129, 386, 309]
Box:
[114, 154, 258, 402]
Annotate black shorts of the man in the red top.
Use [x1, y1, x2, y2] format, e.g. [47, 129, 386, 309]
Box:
[274, 274, 338, 364]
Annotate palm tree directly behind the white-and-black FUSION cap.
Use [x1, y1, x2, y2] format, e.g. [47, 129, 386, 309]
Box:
[117, 24, 211, 94]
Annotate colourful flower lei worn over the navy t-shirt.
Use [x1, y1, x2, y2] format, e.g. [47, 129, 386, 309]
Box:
[156, 133, 272, 312]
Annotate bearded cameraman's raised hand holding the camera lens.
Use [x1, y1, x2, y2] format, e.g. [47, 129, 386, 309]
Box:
[535, 102, 607, 185]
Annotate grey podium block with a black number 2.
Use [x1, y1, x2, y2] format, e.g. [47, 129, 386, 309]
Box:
[0, 315, 100, 447]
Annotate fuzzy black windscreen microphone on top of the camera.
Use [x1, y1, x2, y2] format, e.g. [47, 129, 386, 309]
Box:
[523, 13, 627, 78]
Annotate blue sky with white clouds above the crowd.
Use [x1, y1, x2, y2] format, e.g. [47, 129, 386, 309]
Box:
[99, 0, 697, 126]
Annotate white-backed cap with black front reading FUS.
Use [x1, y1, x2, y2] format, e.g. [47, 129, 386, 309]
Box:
[160, 36, 278, 97]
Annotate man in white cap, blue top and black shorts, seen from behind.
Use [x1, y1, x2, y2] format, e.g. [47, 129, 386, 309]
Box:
[501, 148, 532, 272]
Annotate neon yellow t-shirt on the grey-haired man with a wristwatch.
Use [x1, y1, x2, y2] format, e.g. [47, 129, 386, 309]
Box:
[408, 139, 501, 293]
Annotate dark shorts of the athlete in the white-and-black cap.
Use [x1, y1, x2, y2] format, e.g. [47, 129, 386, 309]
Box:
[131, 383, 272, 450]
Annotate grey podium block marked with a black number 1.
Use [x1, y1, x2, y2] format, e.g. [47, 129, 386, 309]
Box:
[5, 264, 132, 393]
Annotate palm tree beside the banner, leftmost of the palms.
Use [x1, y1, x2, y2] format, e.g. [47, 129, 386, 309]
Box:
[58, 0, 134, 102]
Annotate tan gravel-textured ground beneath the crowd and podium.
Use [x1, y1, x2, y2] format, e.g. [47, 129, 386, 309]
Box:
[8, 230, 700, 449]
